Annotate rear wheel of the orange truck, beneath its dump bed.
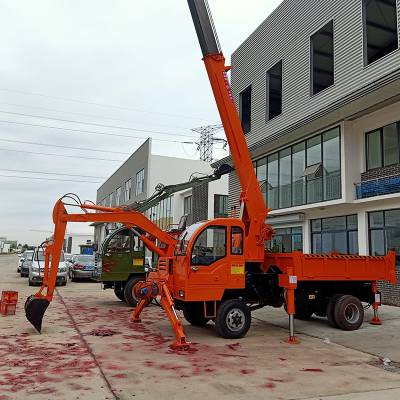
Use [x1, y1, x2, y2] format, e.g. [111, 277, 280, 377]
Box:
[333, 295, 364, 331]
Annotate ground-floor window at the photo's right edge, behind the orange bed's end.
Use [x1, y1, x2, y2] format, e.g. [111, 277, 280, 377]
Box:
[368, 209, 400, 265]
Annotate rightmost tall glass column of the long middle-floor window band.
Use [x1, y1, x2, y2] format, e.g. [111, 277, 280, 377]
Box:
[322, 128, 341, 200]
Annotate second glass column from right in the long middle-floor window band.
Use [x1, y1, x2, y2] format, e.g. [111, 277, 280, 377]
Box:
[307, 135, 322, 203]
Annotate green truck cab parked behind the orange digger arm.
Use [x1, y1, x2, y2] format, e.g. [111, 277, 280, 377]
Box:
[93, 227, 151, 307]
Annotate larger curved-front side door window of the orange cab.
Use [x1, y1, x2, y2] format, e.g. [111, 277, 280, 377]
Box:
[192, 226, 226, 265]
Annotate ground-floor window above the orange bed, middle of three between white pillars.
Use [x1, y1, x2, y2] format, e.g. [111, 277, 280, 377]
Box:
[311, 214, 358, 254]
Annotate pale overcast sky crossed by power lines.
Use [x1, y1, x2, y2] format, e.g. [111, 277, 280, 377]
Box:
[0, 0, 280, 244]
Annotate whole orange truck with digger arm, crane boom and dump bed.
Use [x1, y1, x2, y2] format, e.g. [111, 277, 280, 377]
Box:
[25, 0, 396, 348]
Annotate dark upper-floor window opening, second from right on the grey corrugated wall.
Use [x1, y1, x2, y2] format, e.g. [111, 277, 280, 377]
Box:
[311, 21, 335, 95]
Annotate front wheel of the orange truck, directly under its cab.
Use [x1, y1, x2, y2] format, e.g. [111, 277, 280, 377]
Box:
[215, 299, 251, 339]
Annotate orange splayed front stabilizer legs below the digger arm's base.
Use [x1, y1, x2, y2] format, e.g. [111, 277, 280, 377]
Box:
[131, 282, 191, 350]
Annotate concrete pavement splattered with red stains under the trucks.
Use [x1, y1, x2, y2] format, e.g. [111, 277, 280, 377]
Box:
[0, 256, 400, 400]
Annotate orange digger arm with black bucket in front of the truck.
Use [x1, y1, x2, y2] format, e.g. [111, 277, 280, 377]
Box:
[25, 199, 176, 332]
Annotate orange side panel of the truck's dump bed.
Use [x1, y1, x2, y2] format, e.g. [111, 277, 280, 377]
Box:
[264, 252, 396, 283]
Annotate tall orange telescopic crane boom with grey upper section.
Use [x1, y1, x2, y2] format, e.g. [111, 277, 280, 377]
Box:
[188, 0, 272, 261]
